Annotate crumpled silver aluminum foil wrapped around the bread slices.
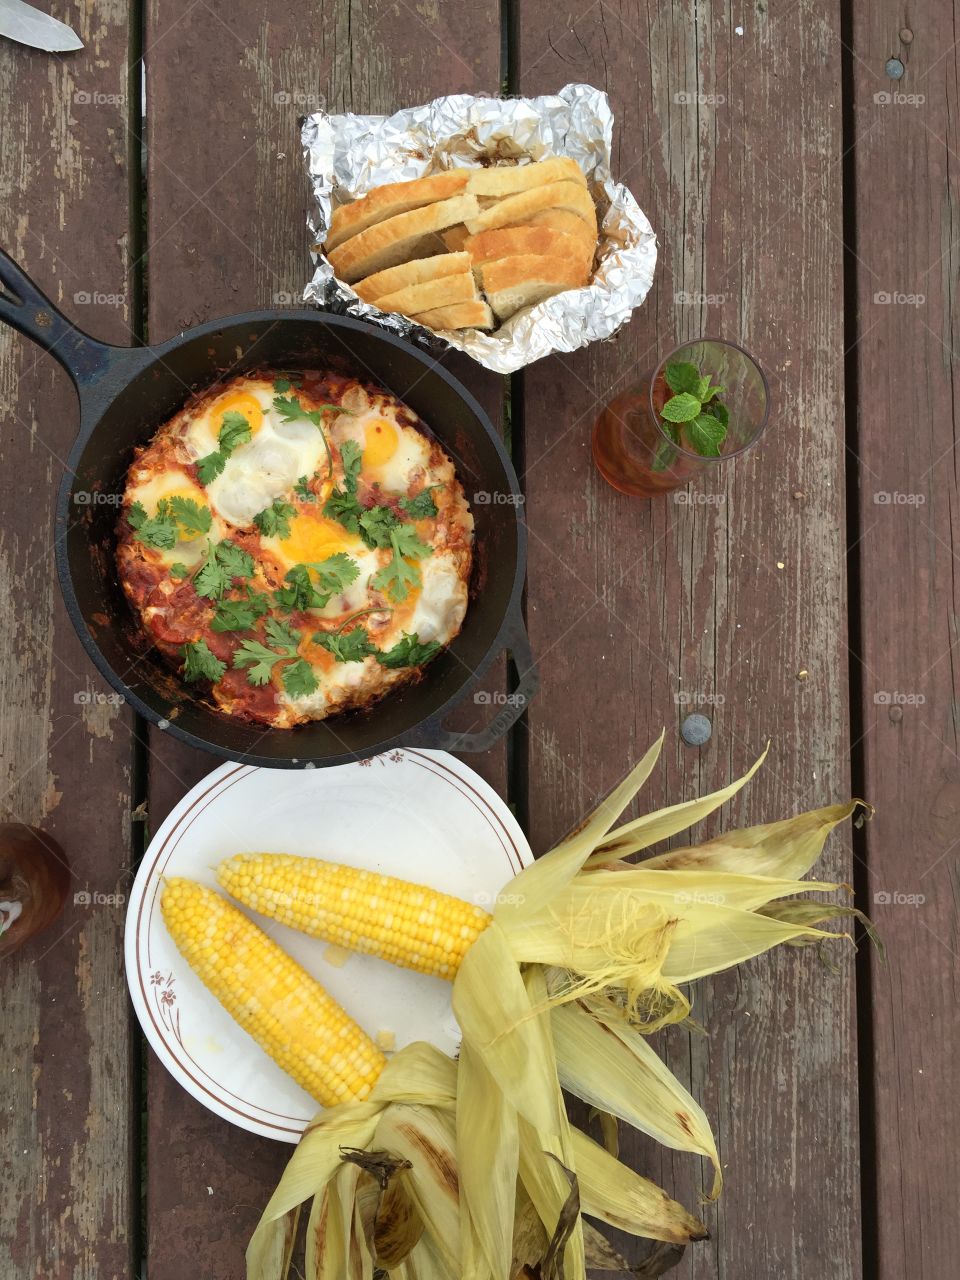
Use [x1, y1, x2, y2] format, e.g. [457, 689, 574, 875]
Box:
[301, 84, 657, 374]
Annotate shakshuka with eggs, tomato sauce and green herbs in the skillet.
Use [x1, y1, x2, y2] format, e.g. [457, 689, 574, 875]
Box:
[116, 372, 474, 728]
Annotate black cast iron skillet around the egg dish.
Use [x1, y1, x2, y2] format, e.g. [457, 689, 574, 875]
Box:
[0, 251, 538, 767]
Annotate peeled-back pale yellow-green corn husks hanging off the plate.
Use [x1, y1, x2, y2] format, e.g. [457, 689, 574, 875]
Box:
[248, 739, 860, 1280]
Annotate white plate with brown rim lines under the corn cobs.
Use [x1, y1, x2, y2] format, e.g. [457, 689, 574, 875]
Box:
[125, 750, 532, 1142]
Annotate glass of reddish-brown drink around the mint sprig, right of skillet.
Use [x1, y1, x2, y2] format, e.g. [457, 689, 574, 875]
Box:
[593, 338, 769, 498]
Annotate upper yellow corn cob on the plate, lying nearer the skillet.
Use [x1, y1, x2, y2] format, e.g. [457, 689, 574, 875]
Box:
[216, 854, 492, 982]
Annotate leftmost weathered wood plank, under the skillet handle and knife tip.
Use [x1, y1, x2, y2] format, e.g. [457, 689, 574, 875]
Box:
[0, 12, 138, 1280]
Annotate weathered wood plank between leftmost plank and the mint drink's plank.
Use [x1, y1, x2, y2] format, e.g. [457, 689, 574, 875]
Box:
[146, 0, 506, 1280]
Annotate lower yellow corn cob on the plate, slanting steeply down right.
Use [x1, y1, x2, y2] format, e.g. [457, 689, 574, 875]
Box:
[161, 878, 387, 1107]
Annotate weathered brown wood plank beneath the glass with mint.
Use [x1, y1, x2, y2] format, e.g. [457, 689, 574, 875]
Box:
[518, 0, 860, 1280]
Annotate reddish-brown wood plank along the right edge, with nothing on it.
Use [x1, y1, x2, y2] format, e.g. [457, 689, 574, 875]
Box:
[854, 12, 960, 1280]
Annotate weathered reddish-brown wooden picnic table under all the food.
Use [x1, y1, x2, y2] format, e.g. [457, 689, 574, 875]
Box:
[0, 0, 960, 1280]
